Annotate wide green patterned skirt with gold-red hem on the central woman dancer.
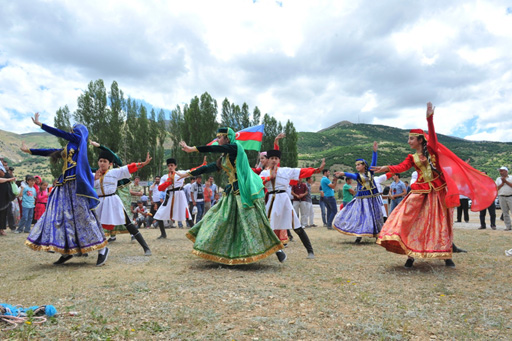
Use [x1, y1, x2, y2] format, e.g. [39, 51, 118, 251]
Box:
[187, 193, 283, 265]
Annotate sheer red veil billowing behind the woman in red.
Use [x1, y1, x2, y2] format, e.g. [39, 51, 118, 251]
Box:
[410, 129, 498, 212]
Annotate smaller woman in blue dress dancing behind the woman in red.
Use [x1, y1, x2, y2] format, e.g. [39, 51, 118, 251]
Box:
[333, 142, 384, 244]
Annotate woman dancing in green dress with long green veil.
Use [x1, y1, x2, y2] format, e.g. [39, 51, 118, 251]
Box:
[180, 128, 286, 265]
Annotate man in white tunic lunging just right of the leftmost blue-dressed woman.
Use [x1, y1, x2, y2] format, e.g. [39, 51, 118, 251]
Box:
[94, 150, 151, 256]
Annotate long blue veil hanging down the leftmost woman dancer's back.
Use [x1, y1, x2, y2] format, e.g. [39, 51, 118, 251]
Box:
[71, 124, 100, 209]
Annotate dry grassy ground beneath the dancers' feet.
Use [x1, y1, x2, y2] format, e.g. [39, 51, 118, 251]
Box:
[0, 211, 512, 340]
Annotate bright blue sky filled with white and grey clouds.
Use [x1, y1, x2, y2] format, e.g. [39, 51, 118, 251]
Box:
[0, 0, 512, 142]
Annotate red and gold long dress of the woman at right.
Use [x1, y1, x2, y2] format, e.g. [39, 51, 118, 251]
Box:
[377, 116, 453, 259]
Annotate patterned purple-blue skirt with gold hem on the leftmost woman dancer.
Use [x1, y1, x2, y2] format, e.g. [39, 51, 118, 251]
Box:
[25, 181, 108, 255]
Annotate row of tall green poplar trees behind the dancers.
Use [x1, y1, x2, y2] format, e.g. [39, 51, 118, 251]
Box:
[51, 79, 298, 183]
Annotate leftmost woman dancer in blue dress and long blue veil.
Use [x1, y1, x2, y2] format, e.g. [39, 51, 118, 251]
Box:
[21, 113, 109, 266]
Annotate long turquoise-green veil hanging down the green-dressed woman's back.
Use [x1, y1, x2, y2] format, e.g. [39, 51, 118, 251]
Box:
[227, 128, 265, 208]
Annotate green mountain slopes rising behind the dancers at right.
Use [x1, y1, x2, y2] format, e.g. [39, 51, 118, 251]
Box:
[297, 121, 512, 178]
